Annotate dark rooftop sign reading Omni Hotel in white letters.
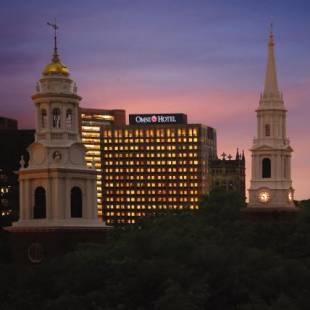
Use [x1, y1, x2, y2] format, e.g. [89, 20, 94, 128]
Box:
[129, 113, 187, 125]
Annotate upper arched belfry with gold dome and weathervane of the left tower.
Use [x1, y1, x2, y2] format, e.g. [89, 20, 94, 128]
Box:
[32, 23, 82, 144]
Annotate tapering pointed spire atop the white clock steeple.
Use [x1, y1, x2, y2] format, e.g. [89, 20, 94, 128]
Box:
[264, 24, 280, 97]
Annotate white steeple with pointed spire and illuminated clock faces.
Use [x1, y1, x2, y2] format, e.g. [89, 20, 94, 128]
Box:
[248, 31, 295, 209]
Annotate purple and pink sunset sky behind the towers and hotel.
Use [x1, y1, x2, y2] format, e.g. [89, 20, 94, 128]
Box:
[0, 0, 310, 199]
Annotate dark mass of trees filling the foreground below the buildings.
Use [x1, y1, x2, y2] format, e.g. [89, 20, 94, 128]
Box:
[0, 191, 310, 310]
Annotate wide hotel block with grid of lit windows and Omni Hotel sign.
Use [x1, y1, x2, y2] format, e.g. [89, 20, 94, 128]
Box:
[101, 114, 216, 224]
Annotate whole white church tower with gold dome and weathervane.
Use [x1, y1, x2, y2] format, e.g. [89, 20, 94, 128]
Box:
[14, 23, 102, 227]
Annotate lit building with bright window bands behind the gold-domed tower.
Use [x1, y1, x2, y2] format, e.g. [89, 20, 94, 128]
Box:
[80, 108, 126, 217]
